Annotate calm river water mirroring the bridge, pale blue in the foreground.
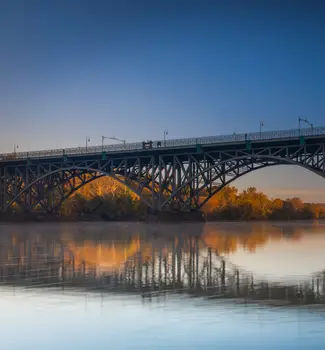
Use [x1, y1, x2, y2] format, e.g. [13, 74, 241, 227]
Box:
[0, 222, 325, 350]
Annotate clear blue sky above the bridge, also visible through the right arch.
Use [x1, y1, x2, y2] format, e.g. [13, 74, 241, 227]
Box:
[0, 0, 325, 202]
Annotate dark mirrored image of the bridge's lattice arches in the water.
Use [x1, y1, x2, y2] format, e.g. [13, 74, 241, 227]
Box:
[0, 224, 325, 305]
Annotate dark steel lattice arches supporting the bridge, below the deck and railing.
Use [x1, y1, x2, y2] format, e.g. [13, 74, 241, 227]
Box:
[0, 144, 325, 211]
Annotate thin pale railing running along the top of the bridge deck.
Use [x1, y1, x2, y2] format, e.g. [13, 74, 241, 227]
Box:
[0, 127, 325, 161]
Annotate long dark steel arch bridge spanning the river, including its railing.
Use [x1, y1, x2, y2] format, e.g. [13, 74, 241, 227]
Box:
[0, 127, 325, 213]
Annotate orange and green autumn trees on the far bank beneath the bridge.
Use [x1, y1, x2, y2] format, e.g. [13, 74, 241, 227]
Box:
[5, 177, 325, 221]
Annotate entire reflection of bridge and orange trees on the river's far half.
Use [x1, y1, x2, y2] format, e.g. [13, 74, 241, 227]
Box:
[0, 223, 325, 305]
